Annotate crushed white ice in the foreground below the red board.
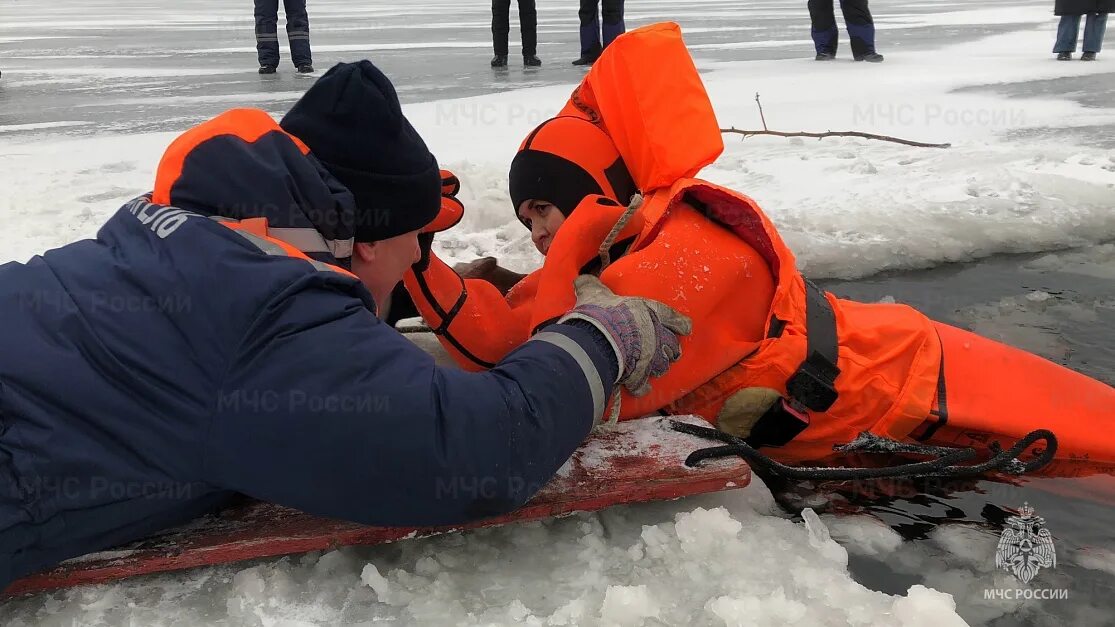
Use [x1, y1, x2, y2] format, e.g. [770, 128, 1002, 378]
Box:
[4, 485, 963, 627]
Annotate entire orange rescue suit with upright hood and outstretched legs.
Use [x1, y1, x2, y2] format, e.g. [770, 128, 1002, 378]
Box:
[406, 23, 1115, 468]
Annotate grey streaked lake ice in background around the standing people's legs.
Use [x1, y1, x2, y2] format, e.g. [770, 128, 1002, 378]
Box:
[0, 0, 1115, 135]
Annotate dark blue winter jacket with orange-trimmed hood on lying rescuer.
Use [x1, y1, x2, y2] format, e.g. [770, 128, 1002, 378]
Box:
[0, 109, 615, 589]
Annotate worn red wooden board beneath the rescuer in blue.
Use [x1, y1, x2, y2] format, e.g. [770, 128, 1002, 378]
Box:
[2, 416, 752, 597]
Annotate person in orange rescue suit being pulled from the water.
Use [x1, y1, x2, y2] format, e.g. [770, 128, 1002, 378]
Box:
[405, 23, 1115, 468]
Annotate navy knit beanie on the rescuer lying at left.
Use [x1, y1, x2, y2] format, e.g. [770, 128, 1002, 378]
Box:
[280, 60, 442, 242]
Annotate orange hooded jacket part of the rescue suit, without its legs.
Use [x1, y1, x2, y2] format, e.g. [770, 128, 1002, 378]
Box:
[405, 23, 941, 459]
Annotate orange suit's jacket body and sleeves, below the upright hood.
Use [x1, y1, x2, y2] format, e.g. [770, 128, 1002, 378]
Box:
[407, 170, 941, 459]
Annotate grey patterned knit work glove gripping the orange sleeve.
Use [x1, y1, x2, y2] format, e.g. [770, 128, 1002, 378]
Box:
[559, 274, 692, 396]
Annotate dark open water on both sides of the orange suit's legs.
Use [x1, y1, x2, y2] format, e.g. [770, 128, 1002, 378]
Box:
[811, 244, 1115, 626]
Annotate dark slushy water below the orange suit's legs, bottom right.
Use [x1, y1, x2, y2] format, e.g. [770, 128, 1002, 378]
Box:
[768, 464, 1115, 627]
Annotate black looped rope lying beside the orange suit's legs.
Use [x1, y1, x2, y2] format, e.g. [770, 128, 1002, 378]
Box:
[670, 421, 1057, 481]
